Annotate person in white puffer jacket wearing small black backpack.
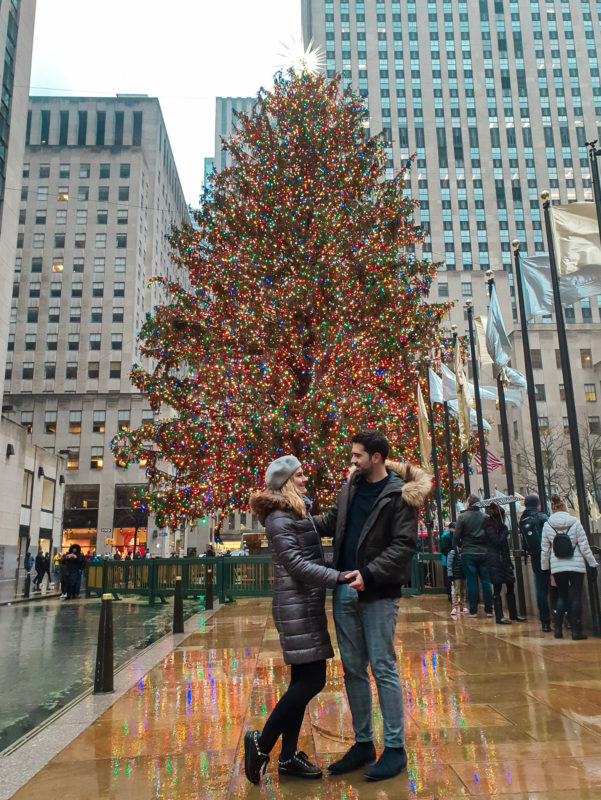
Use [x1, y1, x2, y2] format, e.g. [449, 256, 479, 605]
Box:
[541, 494, 597, 640]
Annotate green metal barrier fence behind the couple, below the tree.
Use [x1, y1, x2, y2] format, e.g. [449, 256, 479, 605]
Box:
[86, 553, 436, 605]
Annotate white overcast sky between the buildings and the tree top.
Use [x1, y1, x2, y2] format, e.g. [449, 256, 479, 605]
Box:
[31, 0, 301, 206]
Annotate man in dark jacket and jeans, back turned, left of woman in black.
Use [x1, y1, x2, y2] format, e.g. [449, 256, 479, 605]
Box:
[454, 494, 493, 617]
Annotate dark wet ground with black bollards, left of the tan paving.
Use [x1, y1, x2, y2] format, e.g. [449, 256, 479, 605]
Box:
[0, 598, 199, 751]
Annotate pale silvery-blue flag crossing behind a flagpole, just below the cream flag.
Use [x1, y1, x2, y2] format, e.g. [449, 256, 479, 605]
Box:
[520, 253, 601, 322]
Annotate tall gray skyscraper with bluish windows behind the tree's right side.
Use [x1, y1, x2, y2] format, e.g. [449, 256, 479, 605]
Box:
[302, 0, 601, 500]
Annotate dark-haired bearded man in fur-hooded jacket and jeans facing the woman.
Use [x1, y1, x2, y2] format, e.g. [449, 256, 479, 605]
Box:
[315, 430, 431, 781]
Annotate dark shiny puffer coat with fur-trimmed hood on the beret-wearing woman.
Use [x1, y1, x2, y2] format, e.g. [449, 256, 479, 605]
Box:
[250, 492, 340, 664]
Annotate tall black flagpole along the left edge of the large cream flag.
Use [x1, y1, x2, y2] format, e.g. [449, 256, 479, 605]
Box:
[540, 191, 601, 636]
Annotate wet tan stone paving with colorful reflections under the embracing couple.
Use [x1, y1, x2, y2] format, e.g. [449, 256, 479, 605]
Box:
[5, 597, 601, 800]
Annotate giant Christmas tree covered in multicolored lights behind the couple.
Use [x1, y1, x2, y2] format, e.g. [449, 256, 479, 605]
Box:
[113, 70, 447, 525]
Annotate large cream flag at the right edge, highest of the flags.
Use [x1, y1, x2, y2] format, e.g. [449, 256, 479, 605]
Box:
[550, 203, 601, 275]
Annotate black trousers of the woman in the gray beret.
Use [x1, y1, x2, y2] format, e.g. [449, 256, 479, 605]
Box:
[259, 659, 326, 761]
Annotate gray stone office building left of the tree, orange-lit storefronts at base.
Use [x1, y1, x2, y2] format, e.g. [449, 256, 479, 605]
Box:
[5, 95, 188, 553]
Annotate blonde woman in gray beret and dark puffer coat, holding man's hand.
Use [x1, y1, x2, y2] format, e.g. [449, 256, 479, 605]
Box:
[244, 456, 345, 783]
